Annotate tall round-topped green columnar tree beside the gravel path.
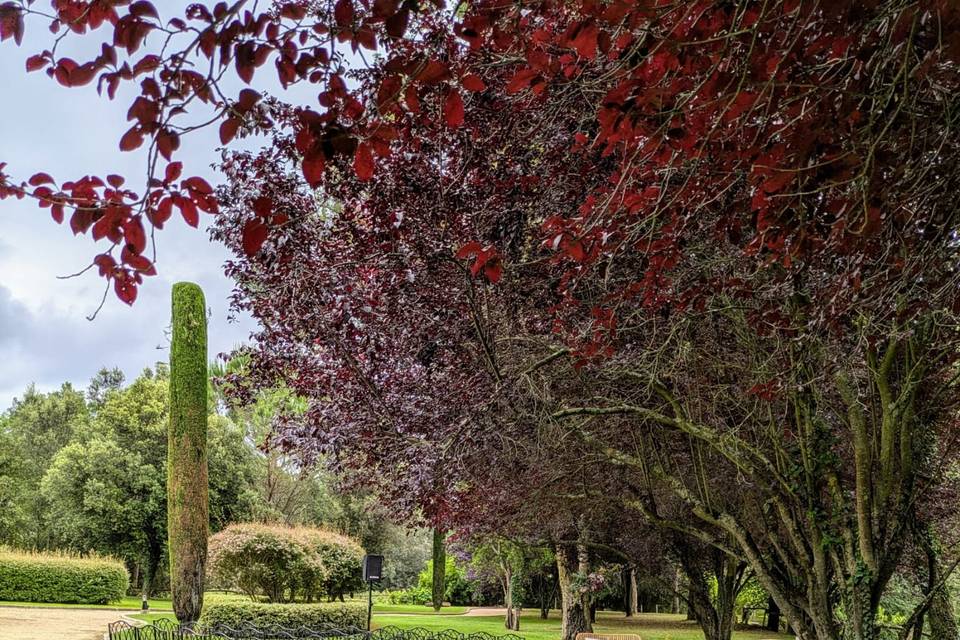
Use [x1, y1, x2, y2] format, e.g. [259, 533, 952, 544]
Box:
[167, 282, 209, 624]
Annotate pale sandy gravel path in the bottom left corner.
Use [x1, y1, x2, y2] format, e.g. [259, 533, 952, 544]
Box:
[0, 607, 129, 640]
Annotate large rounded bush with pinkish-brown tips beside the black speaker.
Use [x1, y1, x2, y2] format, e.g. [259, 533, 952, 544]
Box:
[210, 523, 363, 602]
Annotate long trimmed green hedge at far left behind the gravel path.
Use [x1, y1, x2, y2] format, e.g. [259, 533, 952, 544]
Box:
[0, 550, 130, 604]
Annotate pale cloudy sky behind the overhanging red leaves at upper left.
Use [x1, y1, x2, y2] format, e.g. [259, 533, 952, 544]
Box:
[0, 0, 254, 404]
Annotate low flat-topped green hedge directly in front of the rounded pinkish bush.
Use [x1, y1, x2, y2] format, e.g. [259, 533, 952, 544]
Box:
[200, 602, 367, 629]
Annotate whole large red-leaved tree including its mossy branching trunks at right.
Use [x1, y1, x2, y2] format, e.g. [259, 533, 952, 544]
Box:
[0, 0, 960, 639]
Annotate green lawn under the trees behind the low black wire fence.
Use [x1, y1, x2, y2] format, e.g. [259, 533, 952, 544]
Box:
[124, 605, 793, 640]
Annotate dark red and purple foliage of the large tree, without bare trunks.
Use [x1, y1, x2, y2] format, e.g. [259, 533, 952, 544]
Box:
[0, 0, 960, 552]
